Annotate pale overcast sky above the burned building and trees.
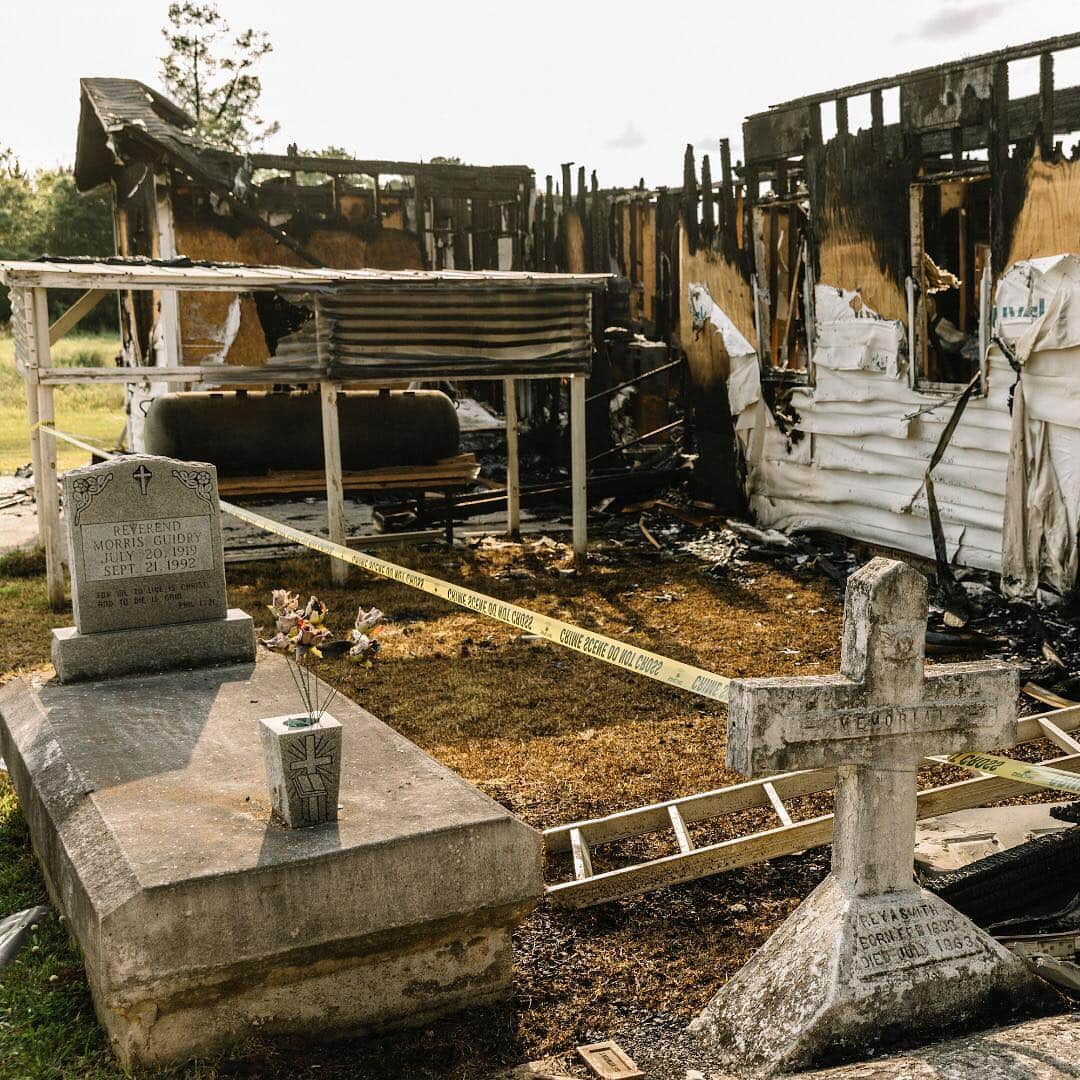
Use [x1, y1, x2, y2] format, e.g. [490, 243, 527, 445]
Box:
[0, 0, 1080, 186]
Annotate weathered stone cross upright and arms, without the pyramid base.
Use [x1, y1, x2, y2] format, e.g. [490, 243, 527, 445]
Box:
[728, 558, 1017, 895]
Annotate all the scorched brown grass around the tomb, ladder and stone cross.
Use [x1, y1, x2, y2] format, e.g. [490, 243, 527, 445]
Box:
[0, 537, 1062, 1078]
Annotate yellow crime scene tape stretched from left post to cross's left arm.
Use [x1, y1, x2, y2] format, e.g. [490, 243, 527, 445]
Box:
[37, 423, 731, 702]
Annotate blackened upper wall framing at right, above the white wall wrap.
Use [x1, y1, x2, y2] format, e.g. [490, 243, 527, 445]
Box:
[740, 33, 1080, 334]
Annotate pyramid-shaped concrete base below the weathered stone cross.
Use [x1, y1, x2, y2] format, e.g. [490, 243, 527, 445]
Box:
[691, 875, 1061, 1072]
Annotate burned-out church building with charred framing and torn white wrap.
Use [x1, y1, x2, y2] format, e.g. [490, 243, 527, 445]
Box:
[77, 35, 1080, 595]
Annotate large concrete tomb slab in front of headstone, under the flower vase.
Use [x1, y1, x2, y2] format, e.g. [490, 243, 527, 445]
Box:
[0, 648, 542, 1066]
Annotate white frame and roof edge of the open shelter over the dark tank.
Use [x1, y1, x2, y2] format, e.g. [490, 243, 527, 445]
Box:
[0, 260, 609, 610]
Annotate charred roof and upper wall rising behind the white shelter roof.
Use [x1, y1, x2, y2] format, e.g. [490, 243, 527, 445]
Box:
[76, 79, 535, 280]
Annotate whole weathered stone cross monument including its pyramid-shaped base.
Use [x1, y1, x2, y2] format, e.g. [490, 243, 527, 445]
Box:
[692, 558, 1044, 1069]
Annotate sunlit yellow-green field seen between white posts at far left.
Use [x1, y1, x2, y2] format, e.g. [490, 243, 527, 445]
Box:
[0, 332, 124, 475]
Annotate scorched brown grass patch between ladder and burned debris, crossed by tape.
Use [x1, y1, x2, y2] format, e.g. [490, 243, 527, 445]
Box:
[230, 552, 840, 828]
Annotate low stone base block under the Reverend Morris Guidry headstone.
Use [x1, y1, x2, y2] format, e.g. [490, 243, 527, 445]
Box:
[52, 608, 255, 683]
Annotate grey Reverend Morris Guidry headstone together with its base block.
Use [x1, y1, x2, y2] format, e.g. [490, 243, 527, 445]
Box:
[52, 455, 255, 683]
